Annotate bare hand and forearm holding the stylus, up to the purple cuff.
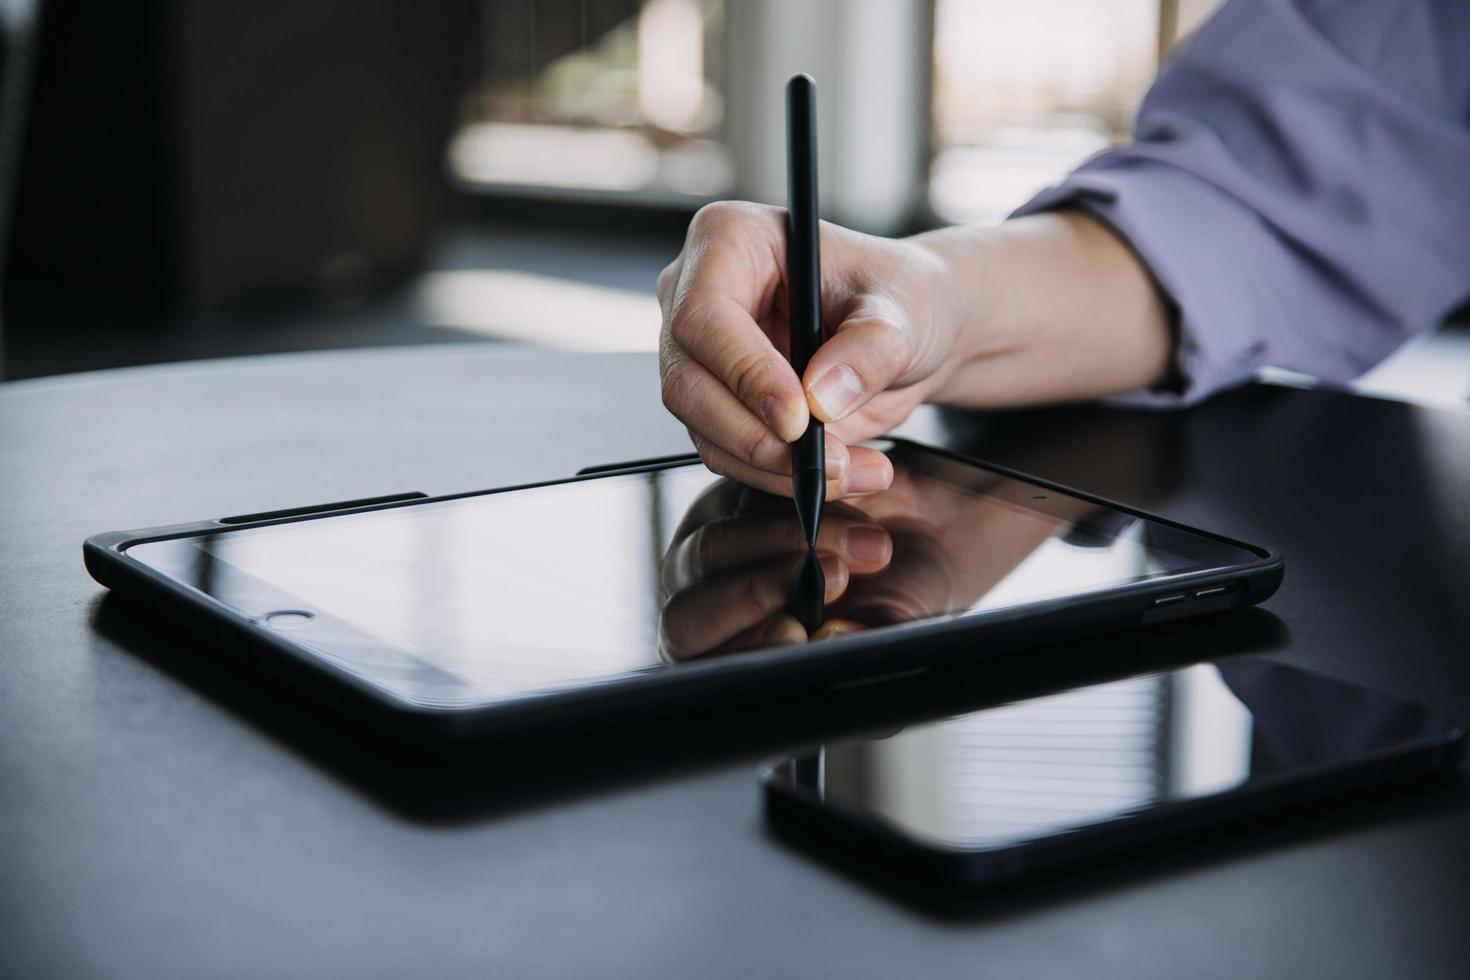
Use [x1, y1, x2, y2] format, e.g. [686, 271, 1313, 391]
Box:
[659, 203, 1177, 500]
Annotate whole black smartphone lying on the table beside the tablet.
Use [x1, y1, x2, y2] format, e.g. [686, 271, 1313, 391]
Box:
[761, 657, 1466, 893]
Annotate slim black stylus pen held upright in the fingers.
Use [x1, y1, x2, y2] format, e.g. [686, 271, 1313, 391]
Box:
[786, 75, 826, 548]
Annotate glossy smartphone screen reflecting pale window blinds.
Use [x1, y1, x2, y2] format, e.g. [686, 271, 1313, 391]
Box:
[767, 657, 1463, 852]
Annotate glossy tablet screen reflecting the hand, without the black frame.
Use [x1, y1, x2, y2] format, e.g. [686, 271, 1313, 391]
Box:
[128, 444, 1258, 704]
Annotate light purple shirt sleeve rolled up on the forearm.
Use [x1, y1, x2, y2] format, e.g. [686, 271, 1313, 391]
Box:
[1017, 0, 1470, 406]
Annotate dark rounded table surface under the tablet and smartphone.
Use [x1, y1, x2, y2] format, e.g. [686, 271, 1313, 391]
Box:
[0, 347, 1470, 977]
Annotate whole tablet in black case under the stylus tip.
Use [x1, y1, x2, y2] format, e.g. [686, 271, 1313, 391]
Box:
[85, 441, 1283, 732]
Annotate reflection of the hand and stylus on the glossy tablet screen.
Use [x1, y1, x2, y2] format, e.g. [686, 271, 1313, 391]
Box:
[660, 466, 1092, 660]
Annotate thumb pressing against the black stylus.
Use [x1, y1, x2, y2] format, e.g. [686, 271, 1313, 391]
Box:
[801, 311, 914, 422]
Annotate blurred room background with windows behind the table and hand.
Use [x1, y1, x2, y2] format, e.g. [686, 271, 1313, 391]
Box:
[0, 0, 1470, 406]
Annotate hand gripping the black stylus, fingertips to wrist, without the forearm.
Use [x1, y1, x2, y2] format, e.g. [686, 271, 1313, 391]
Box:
[659, 203, 956, 500]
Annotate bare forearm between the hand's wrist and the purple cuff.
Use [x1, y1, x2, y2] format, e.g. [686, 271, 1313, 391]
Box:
[914, 212, 1173, 407]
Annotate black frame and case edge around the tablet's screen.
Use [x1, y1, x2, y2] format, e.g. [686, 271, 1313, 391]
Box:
[84, 439, 1285, 733]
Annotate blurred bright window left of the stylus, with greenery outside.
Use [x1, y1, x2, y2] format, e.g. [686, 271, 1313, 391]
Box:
[450, 0, 734, 204]
